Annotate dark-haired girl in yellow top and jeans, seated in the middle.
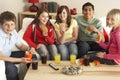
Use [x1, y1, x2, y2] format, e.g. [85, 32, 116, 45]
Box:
[55, 5, 78, 60]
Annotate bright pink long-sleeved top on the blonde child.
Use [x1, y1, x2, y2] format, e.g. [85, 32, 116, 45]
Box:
[99, 27, 120, 65]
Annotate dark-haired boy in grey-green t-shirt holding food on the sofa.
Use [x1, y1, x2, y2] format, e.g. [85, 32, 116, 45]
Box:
[76, 2, 104, 58]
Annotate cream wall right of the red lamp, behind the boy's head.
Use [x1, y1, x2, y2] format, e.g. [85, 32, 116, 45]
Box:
[41, 0, 120, 17]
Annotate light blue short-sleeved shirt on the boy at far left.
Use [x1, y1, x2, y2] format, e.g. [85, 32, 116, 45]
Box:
[0, 28, 21, 56]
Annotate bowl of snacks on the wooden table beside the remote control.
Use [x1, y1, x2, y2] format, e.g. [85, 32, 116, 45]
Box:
[61, 65, 82, 75]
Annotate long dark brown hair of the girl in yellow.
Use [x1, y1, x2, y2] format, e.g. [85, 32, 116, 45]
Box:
[56, 5, 71, 27]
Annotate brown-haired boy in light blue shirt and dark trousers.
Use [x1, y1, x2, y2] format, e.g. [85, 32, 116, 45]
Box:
[0, 11, 34, 80]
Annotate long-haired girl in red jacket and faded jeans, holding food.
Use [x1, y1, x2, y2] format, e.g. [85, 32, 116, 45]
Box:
[23, 8, 57, 59]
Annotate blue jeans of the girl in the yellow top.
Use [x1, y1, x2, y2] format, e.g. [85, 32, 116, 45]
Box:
[57, 42, 78, 60]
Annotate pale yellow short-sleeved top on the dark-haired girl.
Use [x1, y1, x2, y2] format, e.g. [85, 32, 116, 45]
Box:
[55, 19, 78, 39]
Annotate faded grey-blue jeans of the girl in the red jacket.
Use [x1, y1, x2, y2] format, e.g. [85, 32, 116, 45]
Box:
[36, 45, 58, 60]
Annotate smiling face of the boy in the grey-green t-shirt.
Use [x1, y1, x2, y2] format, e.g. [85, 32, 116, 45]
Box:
[82, 6, 94, 21]
